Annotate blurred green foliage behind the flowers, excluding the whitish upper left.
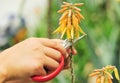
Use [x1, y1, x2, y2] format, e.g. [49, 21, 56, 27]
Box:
[0, 0, 120, 83]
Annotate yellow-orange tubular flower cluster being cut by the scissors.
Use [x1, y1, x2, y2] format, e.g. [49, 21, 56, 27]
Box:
[53, 2, 86, 40]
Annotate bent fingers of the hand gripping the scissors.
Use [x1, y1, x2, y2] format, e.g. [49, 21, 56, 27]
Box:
[34, 38, 77, 70]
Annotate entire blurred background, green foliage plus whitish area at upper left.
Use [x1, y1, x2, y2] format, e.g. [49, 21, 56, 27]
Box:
[0, 0, 120, 83]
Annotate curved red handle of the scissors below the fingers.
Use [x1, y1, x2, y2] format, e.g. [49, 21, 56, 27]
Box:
[32, 56, 64, 82]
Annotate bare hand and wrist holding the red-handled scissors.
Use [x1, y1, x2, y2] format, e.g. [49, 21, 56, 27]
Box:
[0, 38, 76, 83]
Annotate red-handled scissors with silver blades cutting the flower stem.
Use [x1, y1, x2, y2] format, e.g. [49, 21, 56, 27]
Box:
[31, 35, 86, 82]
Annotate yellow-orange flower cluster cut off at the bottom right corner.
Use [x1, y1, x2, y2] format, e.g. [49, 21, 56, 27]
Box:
[89, 65, 120, 83]
